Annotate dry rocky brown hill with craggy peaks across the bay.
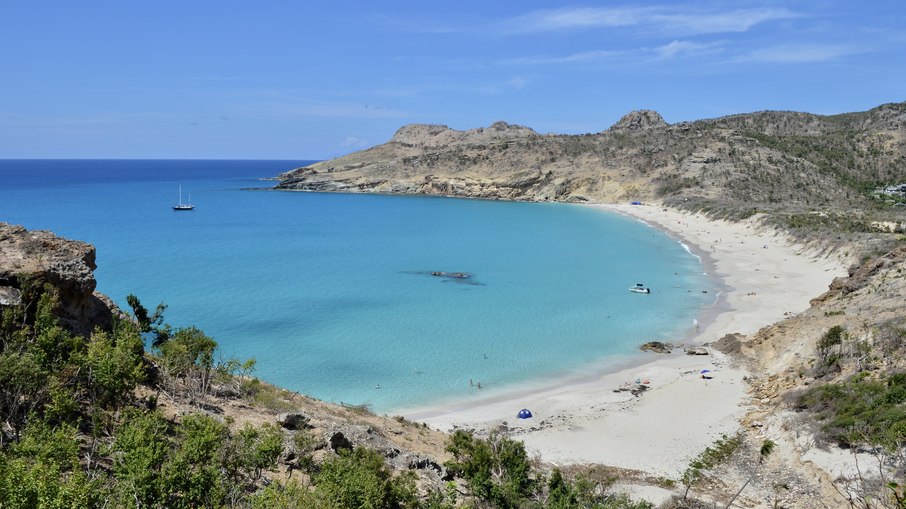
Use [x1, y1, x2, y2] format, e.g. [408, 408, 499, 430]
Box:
[277, 103, 906, 213]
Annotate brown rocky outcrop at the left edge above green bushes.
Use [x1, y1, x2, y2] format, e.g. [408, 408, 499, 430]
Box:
[0, 223, 115, 335]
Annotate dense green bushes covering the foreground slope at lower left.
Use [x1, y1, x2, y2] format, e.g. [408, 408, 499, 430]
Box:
[0, 284, 649, 509]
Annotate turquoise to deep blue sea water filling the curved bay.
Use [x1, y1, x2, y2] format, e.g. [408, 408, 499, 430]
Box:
[0, 160, 711, 413]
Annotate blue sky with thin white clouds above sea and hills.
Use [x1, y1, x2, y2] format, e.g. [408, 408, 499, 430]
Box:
[0, 0, 906, 159]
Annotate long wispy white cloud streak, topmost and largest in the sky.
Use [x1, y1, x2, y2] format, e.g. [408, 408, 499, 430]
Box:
[498, 6, 800, 35]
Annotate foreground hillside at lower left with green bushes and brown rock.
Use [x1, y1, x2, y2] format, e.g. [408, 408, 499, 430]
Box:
[0, 223, 660, 509]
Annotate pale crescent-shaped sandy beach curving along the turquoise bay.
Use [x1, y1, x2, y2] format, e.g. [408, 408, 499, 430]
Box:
[404, 200, 846, 478]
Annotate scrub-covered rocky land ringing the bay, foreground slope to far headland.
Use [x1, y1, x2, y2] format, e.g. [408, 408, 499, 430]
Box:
[0, 103, 906, 509]
